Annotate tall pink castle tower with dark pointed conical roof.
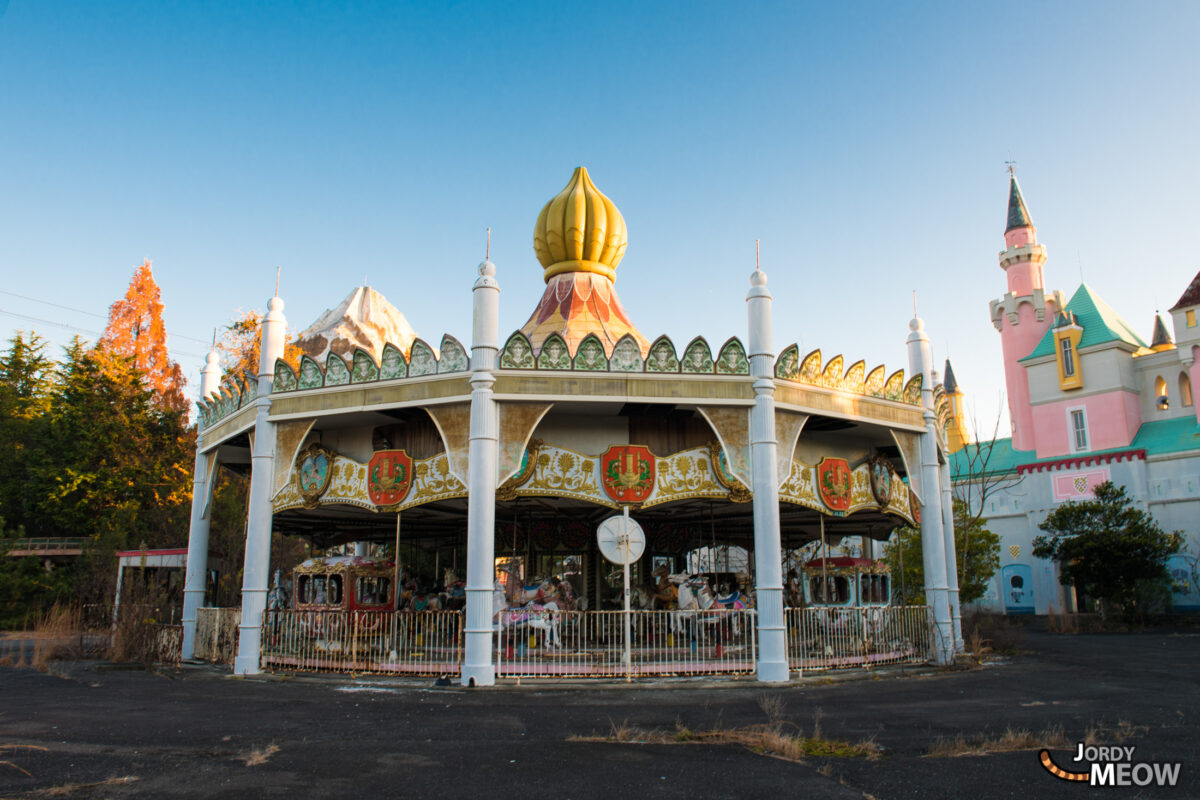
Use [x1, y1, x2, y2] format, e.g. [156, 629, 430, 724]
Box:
[990, 175, 1063, 450]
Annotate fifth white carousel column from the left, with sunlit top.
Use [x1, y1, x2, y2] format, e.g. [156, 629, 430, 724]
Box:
[908, 318, 954, 664]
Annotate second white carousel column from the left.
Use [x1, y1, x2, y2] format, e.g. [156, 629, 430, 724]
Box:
[233, 297, 287, 675]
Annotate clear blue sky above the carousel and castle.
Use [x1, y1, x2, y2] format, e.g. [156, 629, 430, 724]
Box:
[0, 0, 1200, 438]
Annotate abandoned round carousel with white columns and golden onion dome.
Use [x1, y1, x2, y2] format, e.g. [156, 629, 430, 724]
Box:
[184, 167, 960, 685]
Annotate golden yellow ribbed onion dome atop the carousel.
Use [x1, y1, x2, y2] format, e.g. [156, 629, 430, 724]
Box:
[533, 167, 628, 283]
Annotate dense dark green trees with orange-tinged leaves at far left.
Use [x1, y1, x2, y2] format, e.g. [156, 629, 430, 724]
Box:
[0, 333, 196, 618]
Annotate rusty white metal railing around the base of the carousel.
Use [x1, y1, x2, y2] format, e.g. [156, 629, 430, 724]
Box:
[250, 606, 932, 679]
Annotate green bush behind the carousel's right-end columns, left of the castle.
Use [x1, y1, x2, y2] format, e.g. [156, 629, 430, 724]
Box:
[883, 498, 1000, 603]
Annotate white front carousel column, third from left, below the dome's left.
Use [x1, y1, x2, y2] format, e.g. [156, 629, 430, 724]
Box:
[462, 261, 500, 686]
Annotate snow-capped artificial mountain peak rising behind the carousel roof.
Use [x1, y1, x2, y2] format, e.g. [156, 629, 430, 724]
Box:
[296, 287, 416, 363]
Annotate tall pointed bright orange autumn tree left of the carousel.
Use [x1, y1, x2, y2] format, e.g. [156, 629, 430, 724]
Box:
[96, 259, 187, 411]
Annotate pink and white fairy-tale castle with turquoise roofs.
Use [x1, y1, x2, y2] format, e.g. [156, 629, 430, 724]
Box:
[947, 176, 1200, 613]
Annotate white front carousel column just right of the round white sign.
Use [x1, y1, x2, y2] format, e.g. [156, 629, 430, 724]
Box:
[746, 270, 788, 682]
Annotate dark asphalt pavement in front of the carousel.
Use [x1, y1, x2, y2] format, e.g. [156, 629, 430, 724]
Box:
[0, 630, 1200, 800]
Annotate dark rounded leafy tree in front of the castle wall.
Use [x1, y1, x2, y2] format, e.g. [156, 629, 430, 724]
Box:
[1033, 481, 1182, 619]
